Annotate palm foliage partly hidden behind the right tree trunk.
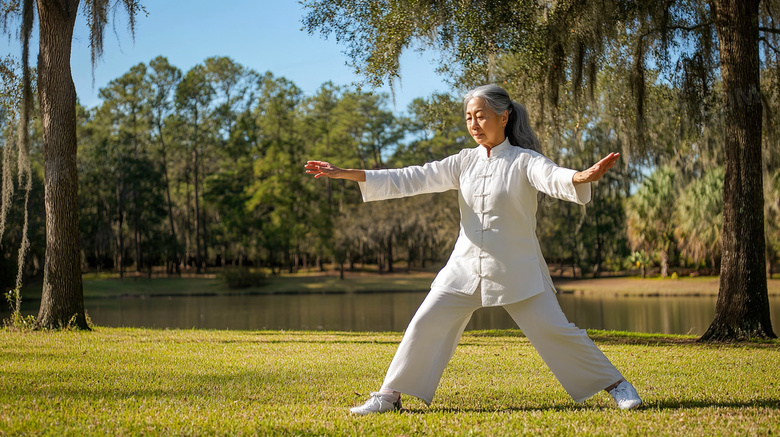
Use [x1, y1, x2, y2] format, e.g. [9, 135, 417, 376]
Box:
[674, 167, 723, 270]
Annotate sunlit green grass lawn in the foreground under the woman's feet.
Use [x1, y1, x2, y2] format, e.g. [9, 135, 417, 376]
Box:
[0, 328, 780, 436]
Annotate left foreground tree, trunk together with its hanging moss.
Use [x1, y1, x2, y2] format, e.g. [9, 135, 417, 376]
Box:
[0, 0, 142, 329]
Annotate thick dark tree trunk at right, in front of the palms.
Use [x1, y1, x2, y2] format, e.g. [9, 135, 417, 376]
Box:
[701, 0, 776, 341]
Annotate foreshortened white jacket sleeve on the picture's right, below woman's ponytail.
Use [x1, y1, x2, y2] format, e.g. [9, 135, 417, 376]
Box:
[526, 152, 591, 205]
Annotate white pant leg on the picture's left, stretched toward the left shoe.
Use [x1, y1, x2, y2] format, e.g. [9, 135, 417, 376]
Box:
[382, 289, 482, 405]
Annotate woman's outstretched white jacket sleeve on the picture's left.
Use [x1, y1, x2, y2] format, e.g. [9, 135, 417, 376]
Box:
[358, 153, 462, 202]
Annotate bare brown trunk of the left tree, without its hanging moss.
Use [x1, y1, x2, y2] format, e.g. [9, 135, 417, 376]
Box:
[37, 0, 89, 329]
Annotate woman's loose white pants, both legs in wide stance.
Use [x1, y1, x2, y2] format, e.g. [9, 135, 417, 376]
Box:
[382, 289, 623, 405]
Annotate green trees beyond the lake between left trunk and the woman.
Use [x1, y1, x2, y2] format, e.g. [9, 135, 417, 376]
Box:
[74, 58, 470, 274]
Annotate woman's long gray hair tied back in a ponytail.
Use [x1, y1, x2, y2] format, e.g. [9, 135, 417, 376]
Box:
[463, 84, 542, 153]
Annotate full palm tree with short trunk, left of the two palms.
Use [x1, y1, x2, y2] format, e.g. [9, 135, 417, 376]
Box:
[626, 167, 677, 278]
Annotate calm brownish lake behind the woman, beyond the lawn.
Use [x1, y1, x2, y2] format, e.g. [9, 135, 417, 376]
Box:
[0, 292, 780, 335]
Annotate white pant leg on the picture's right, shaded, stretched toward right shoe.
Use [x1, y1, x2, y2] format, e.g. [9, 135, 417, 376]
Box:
[504, 291, 623, 402]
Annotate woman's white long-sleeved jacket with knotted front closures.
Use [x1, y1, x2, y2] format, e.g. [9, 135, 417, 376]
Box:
[359, 140, 591, 306]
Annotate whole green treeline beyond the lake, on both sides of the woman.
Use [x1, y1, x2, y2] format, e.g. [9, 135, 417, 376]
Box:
[0, 57, 780, 288]
